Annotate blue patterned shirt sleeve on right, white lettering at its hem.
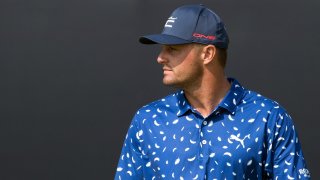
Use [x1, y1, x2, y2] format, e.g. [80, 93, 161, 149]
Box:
[265, 109, 310, 180]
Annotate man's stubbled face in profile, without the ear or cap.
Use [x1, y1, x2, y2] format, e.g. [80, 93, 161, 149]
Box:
[157, 44, 203, 88]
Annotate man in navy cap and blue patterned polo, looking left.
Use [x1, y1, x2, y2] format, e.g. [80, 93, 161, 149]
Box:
[115, 5, 310, 180]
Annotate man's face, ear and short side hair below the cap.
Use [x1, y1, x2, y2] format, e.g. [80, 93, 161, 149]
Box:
[157, 43, 226, 88]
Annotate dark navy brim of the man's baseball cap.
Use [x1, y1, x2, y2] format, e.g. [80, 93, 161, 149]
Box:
[139, 34, 191, 45]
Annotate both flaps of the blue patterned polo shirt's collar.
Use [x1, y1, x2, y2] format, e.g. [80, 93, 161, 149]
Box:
[175, 78, 244, 117]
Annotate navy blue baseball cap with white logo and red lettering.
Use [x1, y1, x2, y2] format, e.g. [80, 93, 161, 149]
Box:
[139, 4, 229, 49]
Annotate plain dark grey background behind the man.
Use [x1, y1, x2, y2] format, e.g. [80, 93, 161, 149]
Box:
[0, 0, 320, 180]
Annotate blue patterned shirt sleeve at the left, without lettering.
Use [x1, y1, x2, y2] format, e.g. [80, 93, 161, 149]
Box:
[114, 115, 144, 180]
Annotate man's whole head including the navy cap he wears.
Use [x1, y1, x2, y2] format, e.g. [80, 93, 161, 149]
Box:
[139, 5, 229, 87]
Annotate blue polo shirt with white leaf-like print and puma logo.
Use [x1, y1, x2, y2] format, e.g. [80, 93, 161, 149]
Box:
[115, 79, 310, 180]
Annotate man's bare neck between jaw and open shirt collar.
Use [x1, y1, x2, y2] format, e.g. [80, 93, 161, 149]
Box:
[184, 74, 230, 117]
